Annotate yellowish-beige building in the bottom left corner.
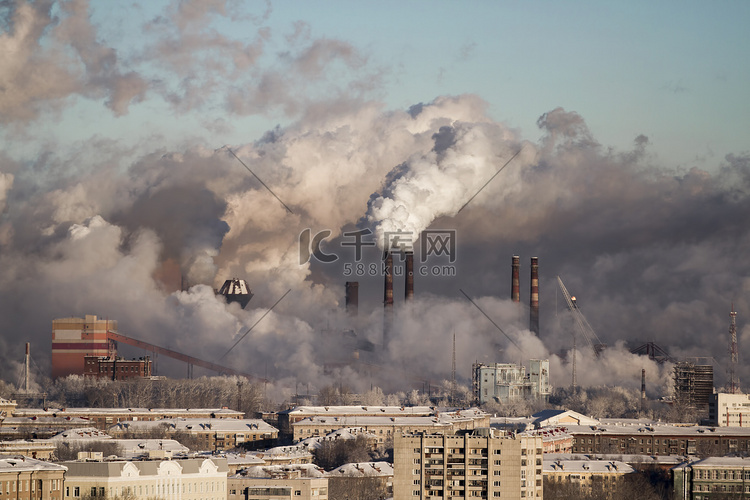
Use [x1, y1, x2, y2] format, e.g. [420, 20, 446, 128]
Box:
[0, 455, 67, 500]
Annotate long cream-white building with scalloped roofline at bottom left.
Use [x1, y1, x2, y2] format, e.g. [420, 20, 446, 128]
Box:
[63, 458, 228, 500]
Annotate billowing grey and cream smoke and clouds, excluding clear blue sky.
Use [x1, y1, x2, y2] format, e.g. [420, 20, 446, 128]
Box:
[0, 1, 750, 402]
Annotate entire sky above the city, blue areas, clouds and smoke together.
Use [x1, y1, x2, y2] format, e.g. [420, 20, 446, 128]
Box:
[0, 0, 750, 396]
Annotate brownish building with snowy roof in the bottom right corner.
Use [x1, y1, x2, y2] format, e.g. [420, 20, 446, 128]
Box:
[672, 457, 750, 500]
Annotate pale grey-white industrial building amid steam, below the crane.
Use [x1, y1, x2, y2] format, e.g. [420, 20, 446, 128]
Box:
[472, 359, 550, 404]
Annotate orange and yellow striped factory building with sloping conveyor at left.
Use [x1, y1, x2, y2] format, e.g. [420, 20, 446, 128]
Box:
[52, 314, 117, 379]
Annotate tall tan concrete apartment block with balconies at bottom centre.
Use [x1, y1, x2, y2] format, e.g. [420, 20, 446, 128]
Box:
[393, 428, 543, 499]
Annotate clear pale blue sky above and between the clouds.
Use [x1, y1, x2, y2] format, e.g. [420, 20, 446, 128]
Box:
[5, 0, 750, 170]
